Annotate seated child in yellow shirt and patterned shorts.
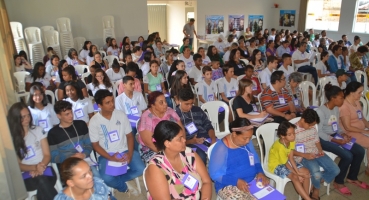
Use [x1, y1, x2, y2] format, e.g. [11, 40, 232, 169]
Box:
[268, 121, 311, 200]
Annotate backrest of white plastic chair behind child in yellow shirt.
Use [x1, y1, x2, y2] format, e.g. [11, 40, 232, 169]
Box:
[256, 123, 279, 170]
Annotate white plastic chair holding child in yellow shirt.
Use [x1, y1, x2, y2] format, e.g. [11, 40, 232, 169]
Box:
[256, 123, 298, 194]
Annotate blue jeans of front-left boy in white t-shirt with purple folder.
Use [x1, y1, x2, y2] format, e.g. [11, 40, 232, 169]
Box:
[99, 151, 145, 192]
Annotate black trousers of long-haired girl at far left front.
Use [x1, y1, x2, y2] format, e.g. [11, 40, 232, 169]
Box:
[24, 169, 58, 200]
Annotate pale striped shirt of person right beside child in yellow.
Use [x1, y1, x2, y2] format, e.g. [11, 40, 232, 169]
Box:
[294, 123, 320, 162]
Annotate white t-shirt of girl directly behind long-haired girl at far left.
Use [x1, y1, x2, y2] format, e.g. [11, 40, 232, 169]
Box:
[28, 103, 59, 132]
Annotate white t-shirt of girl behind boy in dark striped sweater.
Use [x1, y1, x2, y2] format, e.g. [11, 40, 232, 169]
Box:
[64, 97, 94, 123]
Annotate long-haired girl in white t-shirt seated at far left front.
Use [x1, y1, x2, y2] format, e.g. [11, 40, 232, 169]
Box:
[7, 102, 57, 200]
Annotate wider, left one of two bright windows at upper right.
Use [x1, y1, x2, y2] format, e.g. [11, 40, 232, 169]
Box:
[306, 0, 342, 31]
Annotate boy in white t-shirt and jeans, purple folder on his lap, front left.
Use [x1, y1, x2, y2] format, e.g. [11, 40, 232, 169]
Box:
[88, 90, 145, 192]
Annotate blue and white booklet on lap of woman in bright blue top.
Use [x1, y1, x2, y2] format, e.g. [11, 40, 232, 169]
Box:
[248, 179, 286, 200]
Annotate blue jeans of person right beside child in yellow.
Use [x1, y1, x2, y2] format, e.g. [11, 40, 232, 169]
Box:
[301, 154, 340, 189]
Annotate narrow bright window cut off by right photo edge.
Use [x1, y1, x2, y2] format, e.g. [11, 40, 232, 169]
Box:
[352, 0, 369, 33]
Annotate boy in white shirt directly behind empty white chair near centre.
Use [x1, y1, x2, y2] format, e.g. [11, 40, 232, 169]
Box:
[218, 64, 238, 105]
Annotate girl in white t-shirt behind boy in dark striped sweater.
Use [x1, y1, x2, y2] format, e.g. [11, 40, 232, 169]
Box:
[64, 82, 94, 124]
